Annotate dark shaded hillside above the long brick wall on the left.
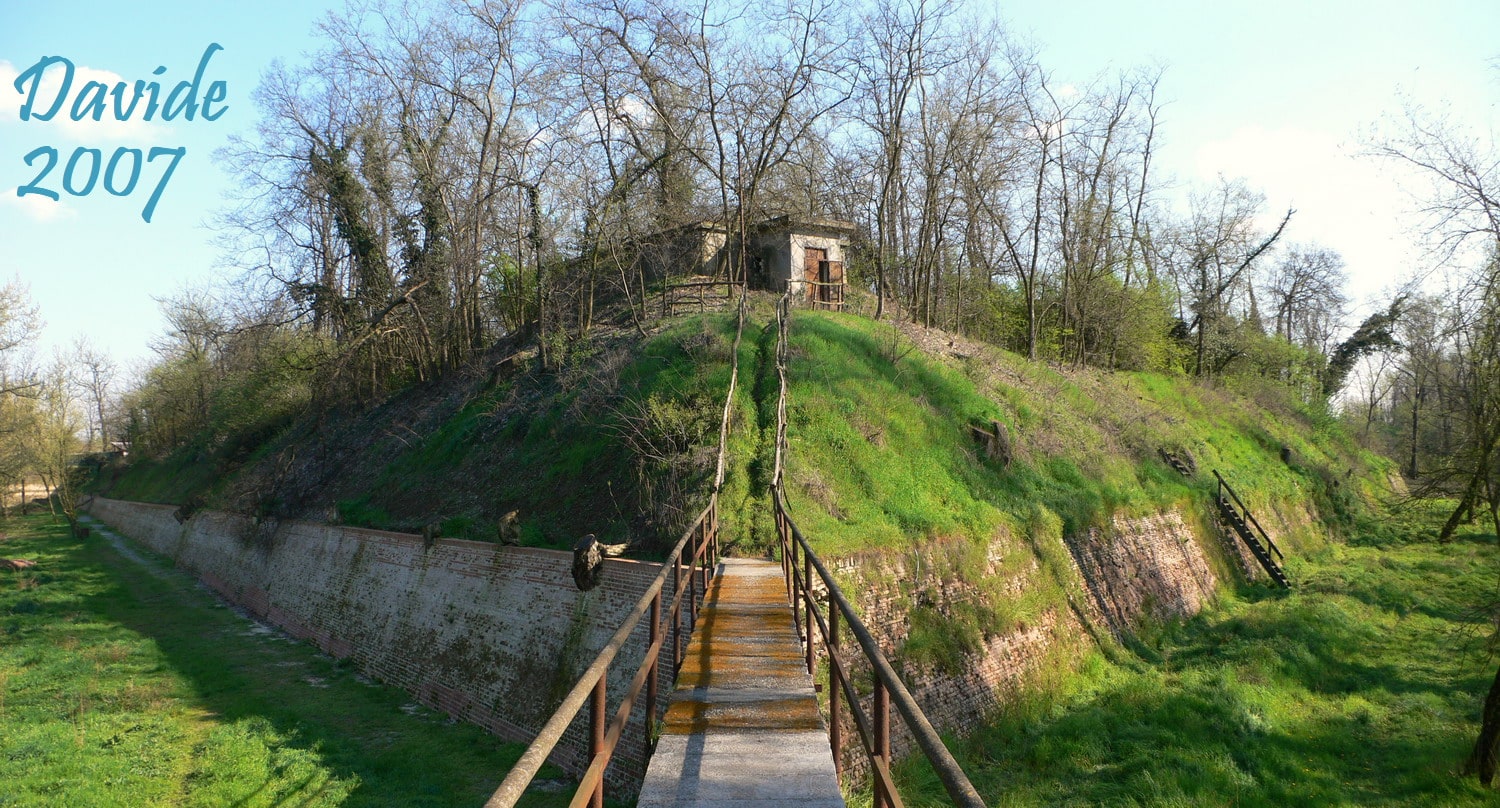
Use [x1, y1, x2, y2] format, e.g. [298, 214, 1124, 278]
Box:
[101, 315, 735, 555]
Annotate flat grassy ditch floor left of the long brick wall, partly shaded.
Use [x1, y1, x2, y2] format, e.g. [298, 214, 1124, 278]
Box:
[0, 517, 566, 807]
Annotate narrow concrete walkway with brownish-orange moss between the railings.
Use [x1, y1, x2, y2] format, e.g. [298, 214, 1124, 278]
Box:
[638, 559, 845, 808]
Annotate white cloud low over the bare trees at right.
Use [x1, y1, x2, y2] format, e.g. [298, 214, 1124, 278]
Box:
[1194, 126, 1421, 310]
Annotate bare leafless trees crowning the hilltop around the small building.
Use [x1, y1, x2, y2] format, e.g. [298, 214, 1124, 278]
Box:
[161, 0, 1346, 410]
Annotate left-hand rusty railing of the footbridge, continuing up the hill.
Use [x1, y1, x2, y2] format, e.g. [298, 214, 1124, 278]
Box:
[485, 291, 746, 808]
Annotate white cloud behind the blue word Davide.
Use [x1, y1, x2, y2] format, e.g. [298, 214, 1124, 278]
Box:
[0, 60, 167, 145]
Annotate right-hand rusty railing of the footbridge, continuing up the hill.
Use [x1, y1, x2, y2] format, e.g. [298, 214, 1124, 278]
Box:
[771, 295, 984, 808]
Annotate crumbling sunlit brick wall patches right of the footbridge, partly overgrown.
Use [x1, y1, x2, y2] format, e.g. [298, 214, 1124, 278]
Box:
[831, 511, 1217, 771]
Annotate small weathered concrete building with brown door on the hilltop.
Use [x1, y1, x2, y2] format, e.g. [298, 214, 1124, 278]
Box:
[641, 216, 855, 309]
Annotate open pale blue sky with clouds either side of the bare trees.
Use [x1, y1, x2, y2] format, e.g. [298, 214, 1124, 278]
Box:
[0, 0, 1500, 376]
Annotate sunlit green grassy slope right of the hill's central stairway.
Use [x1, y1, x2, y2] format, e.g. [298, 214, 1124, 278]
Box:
[788, 312, 1391, 555]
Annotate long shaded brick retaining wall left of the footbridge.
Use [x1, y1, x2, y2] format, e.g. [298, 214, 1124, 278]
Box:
[89, 498, 686, 793]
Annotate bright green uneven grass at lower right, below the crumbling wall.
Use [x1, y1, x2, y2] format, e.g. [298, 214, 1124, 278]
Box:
[905, 503, 1500, 807]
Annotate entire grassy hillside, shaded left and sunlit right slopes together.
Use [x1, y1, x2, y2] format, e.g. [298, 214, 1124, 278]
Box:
[101, 298, 1385, 566]
